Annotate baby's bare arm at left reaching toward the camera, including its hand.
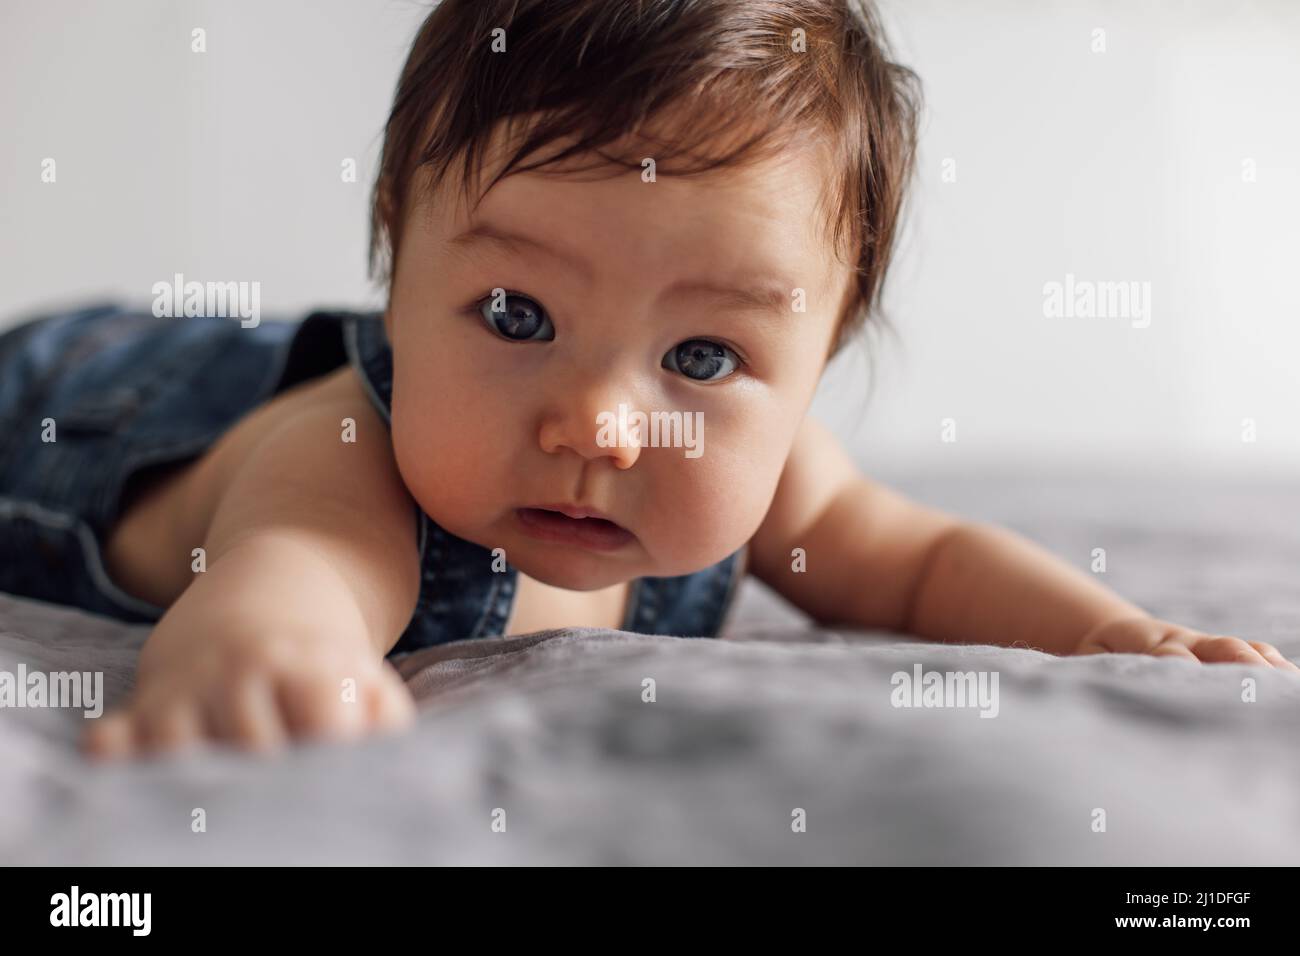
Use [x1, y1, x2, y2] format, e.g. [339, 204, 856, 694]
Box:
[86, 399, 419, 756]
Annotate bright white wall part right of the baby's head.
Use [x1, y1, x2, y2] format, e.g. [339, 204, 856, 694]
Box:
[816, 0, 1300, 476]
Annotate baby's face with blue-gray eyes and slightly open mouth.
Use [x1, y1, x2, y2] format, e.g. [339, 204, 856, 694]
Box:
[385, 134, 850, 591]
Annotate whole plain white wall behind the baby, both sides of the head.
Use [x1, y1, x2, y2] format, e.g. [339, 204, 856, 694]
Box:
[0, 0, 1300, 477]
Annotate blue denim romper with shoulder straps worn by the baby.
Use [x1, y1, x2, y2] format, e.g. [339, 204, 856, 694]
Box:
[0, 304, 745, 658]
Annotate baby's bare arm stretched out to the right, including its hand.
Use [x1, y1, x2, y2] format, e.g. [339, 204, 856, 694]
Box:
[750, 419, 1300, 670]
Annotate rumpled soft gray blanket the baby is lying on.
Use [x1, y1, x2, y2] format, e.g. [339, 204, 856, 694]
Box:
[0, 479, 1300, 865]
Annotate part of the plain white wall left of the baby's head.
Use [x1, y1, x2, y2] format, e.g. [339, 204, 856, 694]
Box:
[0, 0, 425, 323]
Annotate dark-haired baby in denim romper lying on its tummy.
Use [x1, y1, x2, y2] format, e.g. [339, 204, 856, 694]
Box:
[0, 0, 1300, 756]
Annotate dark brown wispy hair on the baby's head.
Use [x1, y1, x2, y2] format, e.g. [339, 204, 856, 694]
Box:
[371, 0, 920, 354]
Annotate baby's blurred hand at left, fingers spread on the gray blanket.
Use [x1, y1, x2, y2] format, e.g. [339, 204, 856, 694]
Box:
[82, 633, 415, 758]
